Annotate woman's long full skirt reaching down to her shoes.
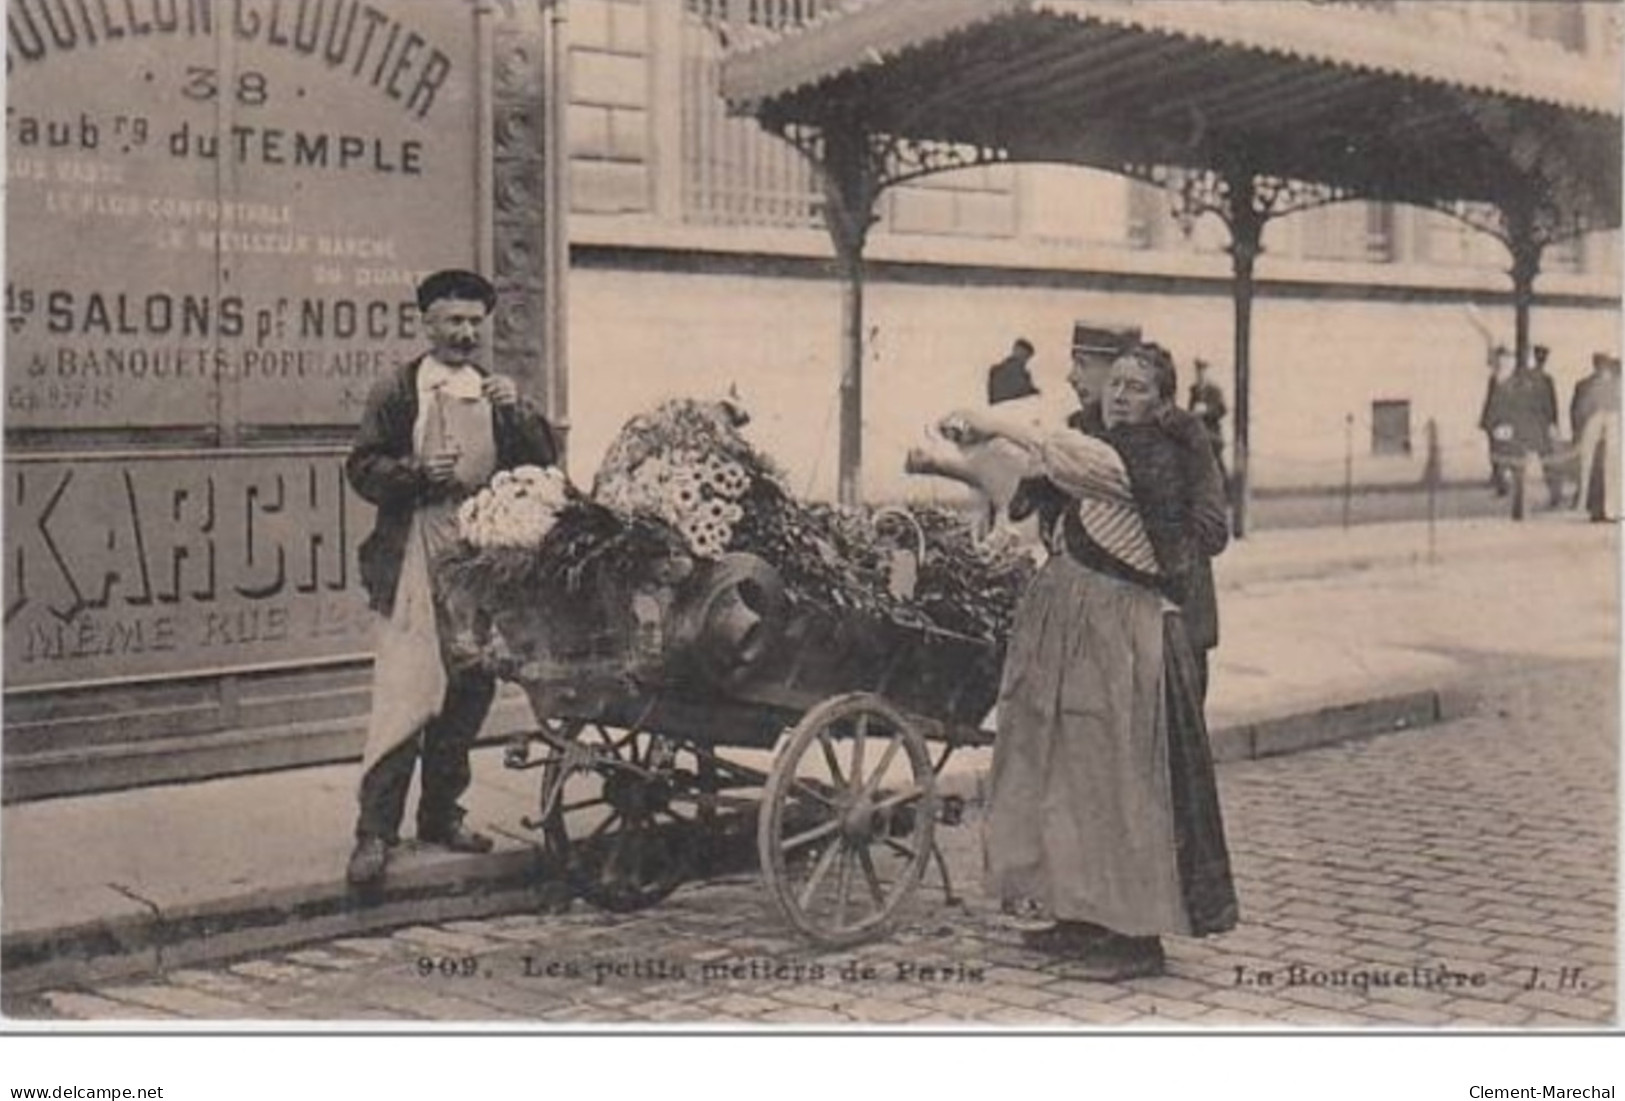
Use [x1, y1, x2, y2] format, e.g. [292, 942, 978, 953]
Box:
[986, 554, 1237, 935]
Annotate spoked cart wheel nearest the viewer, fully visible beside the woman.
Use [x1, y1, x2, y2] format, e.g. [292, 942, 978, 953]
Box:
[756, 692, 936, 947]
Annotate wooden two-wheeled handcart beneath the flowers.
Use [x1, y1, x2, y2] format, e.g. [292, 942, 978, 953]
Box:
[477, 554, 1001, 945]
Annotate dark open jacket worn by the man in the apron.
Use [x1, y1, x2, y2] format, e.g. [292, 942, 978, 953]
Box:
[345, 356, 559, 615]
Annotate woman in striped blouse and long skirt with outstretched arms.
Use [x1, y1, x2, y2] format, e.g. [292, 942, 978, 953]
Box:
[944, 346, 1237, 981]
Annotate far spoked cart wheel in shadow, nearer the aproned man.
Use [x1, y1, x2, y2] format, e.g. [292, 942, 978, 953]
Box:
[541, 723, 713, 913]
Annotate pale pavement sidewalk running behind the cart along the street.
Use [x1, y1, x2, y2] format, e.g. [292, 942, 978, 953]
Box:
[0, 515, 1619, 994]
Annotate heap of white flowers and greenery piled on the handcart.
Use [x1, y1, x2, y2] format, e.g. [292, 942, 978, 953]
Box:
[442, 399, 1032, 645]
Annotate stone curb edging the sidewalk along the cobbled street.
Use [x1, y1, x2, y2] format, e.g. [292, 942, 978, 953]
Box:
[0, 689, 1472, 999]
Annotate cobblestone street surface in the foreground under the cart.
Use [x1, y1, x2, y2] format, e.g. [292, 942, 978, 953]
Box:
[8, 658, 1617, 1028]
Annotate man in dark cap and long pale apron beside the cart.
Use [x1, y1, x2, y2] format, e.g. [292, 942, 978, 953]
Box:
[345, 270, 559, 887]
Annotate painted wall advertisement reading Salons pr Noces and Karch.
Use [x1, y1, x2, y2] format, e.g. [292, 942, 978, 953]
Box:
[5, 0, 481, 689]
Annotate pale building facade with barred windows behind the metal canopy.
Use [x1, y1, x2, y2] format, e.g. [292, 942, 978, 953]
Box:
[555, 0, 1619, 499]
